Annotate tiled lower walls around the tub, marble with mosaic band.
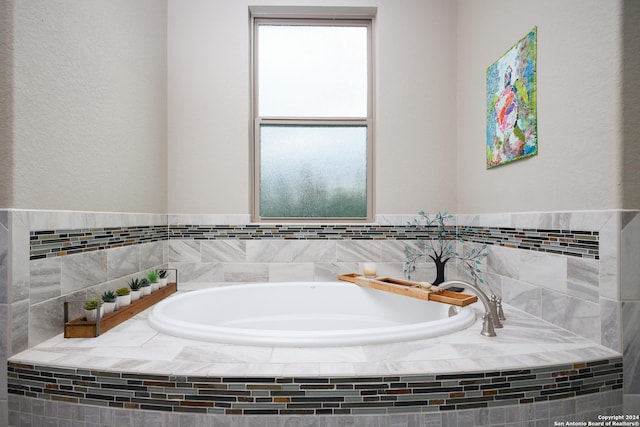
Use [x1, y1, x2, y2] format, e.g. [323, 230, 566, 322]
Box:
[2, 211, 619, 353]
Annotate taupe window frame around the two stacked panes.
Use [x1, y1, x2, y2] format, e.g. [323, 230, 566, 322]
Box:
[249, 10, 376, 223]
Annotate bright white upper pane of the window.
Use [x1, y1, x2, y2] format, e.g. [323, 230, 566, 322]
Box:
[258, 25, 368, 117]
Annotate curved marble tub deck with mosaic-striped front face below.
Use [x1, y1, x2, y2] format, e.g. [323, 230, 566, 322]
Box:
[10, 300, 622, 426]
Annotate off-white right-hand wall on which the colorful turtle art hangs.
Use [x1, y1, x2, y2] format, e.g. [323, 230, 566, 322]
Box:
[457, 0, 622, 213]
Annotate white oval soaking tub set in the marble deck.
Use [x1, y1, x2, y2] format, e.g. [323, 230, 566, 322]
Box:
[149, 282, 475, 347]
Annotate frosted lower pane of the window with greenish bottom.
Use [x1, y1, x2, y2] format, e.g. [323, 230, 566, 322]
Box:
[260, 125, 367, 218]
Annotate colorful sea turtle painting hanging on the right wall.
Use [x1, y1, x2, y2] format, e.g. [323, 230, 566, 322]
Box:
[487, 28, 538, 169]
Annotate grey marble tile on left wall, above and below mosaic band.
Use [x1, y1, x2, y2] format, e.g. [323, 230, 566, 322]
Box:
[0, 210, 167, 355]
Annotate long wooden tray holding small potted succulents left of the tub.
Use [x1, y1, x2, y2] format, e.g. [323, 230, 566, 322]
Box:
[64, 282, 178, 338]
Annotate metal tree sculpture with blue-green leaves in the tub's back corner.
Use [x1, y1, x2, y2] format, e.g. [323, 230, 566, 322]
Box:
[403, 211, 488, 285]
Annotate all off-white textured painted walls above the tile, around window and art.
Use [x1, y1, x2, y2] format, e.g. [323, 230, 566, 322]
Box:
[6, 0, 640, 214]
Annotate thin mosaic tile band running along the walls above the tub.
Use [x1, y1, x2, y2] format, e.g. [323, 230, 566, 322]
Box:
[30, 224, 599, 260]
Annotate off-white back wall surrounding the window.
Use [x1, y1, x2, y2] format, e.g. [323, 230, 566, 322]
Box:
[168, 0, 456, 214]
